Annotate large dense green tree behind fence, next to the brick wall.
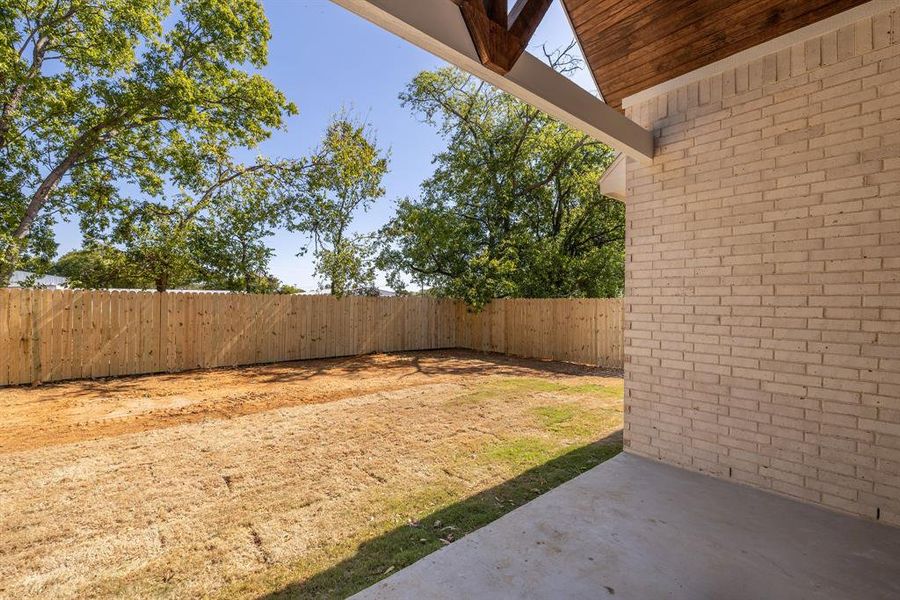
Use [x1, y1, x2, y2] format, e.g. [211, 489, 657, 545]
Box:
[378, 51, 625, 306]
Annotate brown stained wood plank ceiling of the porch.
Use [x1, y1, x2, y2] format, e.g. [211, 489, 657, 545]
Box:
[561, 0, 867, 109]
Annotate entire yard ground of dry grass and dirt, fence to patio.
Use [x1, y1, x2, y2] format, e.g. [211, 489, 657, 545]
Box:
[0, 352, 622, 598]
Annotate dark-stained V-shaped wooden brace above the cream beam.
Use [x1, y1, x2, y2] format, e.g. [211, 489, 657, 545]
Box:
[453, 0, 553, 75]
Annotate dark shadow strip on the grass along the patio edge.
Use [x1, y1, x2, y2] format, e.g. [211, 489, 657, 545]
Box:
[262, 431, 622, 600]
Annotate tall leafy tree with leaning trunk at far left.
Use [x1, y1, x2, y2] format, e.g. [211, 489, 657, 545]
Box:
[0, 0, 296, 285]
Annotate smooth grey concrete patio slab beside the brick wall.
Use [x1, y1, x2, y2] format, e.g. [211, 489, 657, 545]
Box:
[354, 454, 900, 600]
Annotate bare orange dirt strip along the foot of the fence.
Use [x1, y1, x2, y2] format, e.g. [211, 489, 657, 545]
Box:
[0, 352, 615, 453]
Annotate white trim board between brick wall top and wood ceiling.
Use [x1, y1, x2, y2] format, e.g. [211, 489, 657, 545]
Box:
[622, 0, 900, 108]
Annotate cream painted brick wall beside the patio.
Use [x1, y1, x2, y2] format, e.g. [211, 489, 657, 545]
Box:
[625, 8, 900, 524]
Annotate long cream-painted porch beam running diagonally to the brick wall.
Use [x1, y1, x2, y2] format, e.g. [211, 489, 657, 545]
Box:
[332, 0, 653, 164]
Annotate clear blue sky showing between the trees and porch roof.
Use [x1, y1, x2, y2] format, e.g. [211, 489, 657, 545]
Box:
[57, 0, 593, 290]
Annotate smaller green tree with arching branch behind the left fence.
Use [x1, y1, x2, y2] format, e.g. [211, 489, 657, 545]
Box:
[103, 157, 298, 292]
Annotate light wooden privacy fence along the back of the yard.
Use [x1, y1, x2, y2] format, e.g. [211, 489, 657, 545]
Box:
[0, 288, 624, 385]
